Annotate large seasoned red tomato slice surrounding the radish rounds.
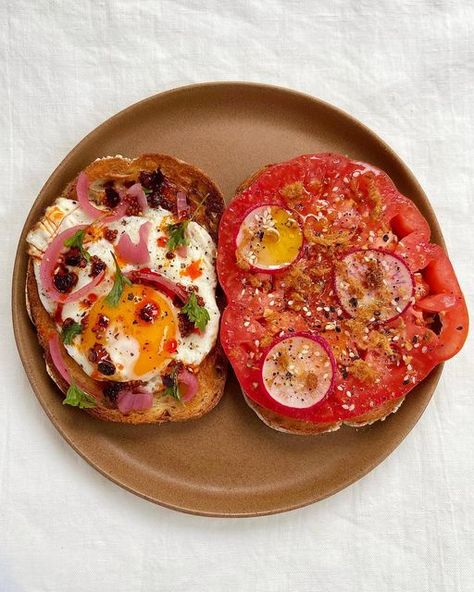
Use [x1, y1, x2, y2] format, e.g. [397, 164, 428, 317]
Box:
[217, 154, 468, 423]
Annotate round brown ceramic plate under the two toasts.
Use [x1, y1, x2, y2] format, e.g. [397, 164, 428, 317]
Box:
[13, 83, 442, 516]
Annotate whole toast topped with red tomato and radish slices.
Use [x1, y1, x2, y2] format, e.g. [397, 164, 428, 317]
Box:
[217, 153, 468, 435]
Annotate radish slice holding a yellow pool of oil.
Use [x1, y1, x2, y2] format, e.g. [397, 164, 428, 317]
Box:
[236, 204, 303, 272]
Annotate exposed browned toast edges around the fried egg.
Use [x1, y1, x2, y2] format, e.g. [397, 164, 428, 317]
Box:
[26, 154, 227, 424]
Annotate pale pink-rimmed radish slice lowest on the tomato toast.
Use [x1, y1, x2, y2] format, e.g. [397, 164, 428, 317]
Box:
[261, 333, 336, 409]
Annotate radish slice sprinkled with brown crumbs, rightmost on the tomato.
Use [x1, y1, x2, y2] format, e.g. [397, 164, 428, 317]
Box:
[334, 249, 415, 323]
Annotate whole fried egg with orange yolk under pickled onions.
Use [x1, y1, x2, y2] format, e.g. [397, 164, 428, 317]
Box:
[27, 197, 219, 387]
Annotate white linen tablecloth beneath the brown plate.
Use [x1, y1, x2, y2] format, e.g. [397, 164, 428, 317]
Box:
[0, 0, 474, 592]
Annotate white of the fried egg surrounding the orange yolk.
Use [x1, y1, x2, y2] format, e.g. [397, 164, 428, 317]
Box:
[27, 197, 219, 388]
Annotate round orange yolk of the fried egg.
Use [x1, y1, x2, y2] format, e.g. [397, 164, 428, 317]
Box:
[80, 284, 177, 380]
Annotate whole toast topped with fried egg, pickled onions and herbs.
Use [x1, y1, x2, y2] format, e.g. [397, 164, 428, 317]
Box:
[26, 154, 226, 424]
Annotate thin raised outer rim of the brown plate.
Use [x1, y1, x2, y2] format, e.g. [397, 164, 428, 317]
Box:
[11, 81, 446, 518]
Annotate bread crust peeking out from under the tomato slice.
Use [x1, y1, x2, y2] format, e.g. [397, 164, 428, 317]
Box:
[236, 164, 405, 436]
